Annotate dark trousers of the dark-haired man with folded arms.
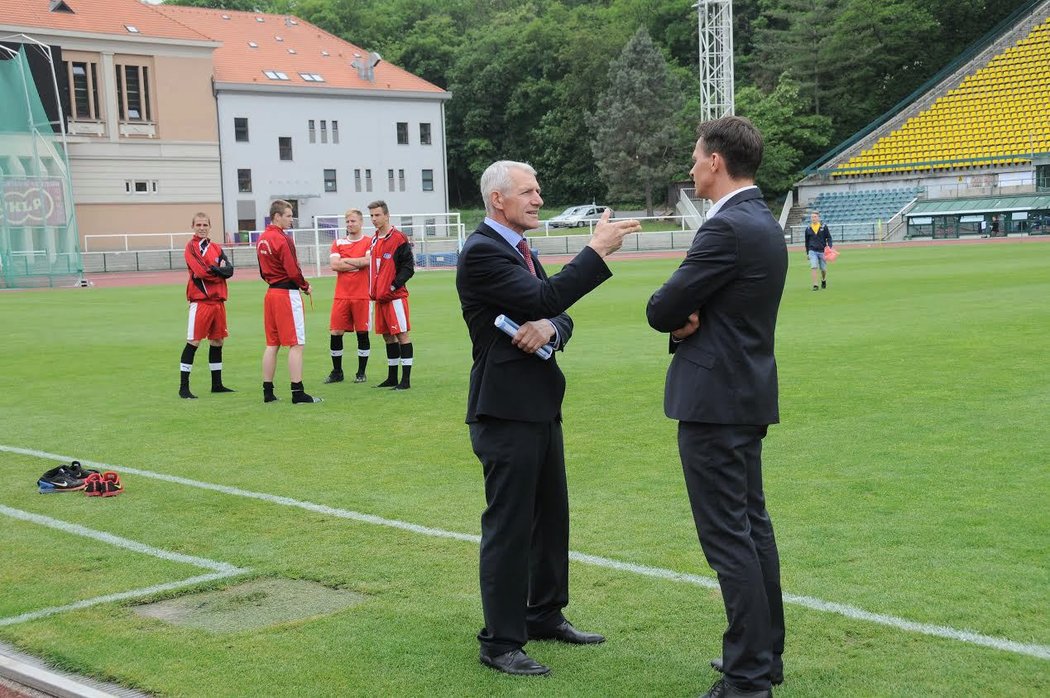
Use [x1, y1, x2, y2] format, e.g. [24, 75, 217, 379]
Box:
[678, 422, 784, 691]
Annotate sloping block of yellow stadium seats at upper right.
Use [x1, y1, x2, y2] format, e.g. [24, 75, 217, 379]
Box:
[832, 20, 1050, 176]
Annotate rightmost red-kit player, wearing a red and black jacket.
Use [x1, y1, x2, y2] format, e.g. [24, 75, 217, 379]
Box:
[369, 202, 416, 390]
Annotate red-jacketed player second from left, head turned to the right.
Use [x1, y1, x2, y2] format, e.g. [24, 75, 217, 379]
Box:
[255, 198, 321, 403]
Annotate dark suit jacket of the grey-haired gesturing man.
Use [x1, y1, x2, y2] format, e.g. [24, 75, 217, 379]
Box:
[456, 223, 612, 423]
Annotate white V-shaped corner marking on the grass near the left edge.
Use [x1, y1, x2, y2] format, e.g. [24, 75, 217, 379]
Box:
[0, 501, 248, 628]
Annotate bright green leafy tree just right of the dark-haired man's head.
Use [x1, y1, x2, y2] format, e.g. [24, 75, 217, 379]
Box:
[736, 73, 832, 197]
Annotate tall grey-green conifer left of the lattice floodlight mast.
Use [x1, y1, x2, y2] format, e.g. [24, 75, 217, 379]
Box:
[587, 26, 683, 215]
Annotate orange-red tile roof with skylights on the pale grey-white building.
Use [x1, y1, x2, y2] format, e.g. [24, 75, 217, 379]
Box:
[154, 5, 444, 93]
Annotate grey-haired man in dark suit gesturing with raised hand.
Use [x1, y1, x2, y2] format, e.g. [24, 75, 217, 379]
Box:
[456, 161, 641, 675]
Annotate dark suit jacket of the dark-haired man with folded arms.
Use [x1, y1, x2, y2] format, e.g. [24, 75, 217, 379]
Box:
[646, 189, 788, 425]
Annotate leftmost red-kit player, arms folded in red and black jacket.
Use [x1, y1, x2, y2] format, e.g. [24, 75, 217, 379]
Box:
[179, 213, 233, 400]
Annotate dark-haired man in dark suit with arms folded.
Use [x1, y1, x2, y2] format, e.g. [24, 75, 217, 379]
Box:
[646, 117, 788, 698]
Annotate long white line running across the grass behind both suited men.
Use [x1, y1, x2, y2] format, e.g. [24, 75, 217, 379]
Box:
[0, 444, 1050, 659]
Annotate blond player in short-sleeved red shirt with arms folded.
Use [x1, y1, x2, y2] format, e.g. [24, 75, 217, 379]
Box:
[324, 209, 372, 383]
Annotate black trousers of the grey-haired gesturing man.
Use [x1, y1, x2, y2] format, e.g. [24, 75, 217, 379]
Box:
[470, 418, 569, 655]
